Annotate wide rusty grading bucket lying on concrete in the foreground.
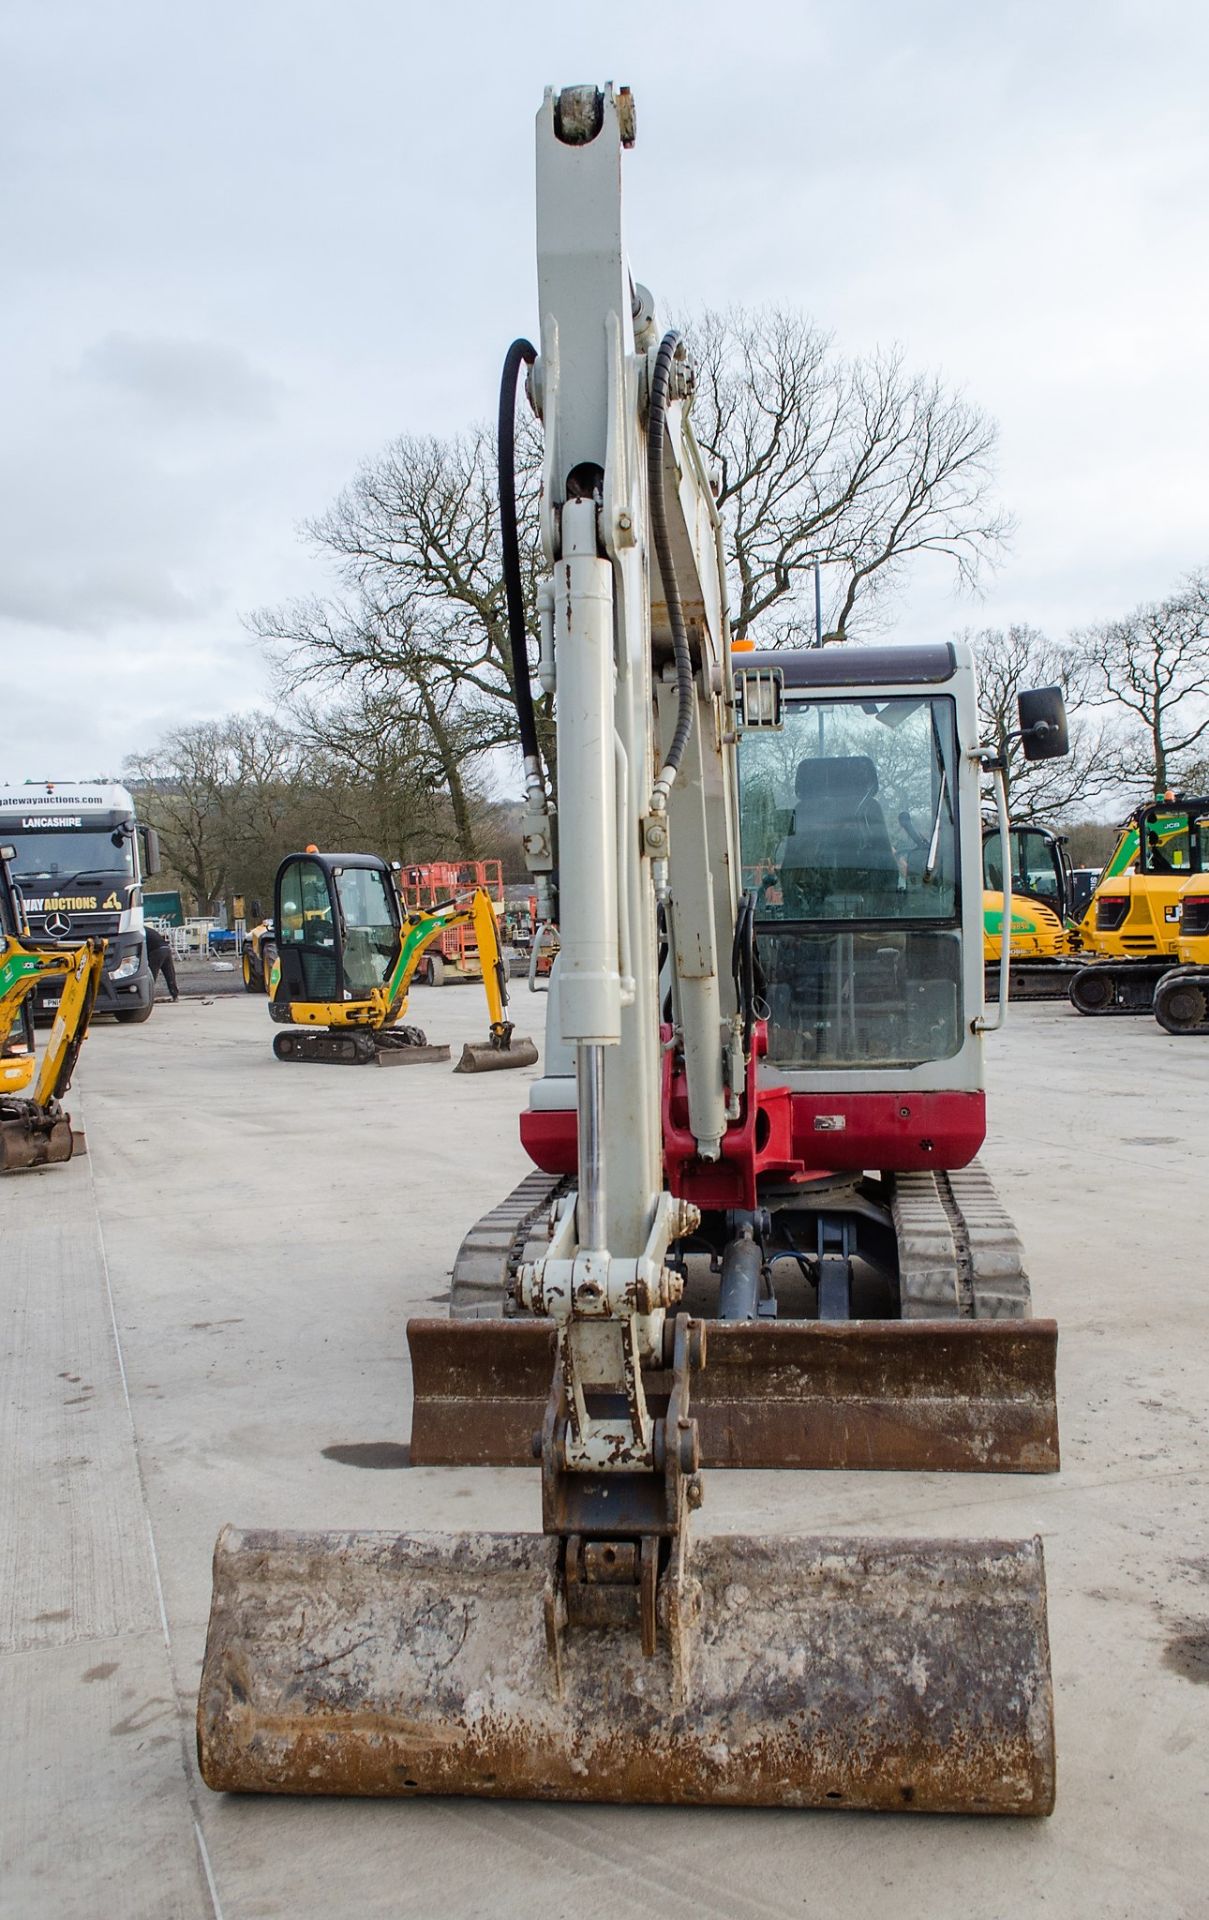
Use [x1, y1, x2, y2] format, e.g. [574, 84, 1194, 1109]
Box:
[198, 1528, 1054, 1814]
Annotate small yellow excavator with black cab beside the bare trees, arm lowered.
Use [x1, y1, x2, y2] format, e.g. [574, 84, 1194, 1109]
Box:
[269, 847, 537, 1073]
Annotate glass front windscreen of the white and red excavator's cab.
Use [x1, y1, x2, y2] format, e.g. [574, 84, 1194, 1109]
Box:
[739, 668, 967, 1073]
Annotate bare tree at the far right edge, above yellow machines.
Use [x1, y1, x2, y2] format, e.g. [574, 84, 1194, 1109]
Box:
[1077, 570, 1209, 793]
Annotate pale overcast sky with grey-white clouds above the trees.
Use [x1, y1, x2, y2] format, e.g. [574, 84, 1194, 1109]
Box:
[0, 0, 1209, 780]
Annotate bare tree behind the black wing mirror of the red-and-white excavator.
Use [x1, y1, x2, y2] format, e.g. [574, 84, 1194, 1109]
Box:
[961, 626, 1121, 820]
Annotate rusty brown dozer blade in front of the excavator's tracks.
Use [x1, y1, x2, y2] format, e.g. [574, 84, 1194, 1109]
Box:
[407, 1319, 1059, 1473]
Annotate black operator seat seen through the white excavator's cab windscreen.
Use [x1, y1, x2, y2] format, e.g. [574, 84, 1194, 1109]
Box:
[781, 753, 900, 920]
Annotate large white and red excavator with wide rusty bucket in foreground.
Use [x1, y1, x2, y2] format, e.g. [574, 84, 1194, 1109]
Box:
[198, 86, 1065, 1814]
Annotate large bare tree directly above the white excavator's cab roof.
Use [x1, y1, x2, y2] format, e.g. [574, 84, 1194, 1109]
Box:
[687, 307, 1011, 645]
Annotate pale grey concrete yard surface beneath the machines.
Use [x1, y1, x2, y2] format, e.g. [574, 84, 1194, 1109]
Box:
[0, 983, 1209, 1920]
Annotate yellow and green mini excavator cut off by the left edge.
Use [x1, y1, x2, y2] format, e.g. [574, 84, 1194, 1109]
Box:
[0, 847, 106, 1173]
